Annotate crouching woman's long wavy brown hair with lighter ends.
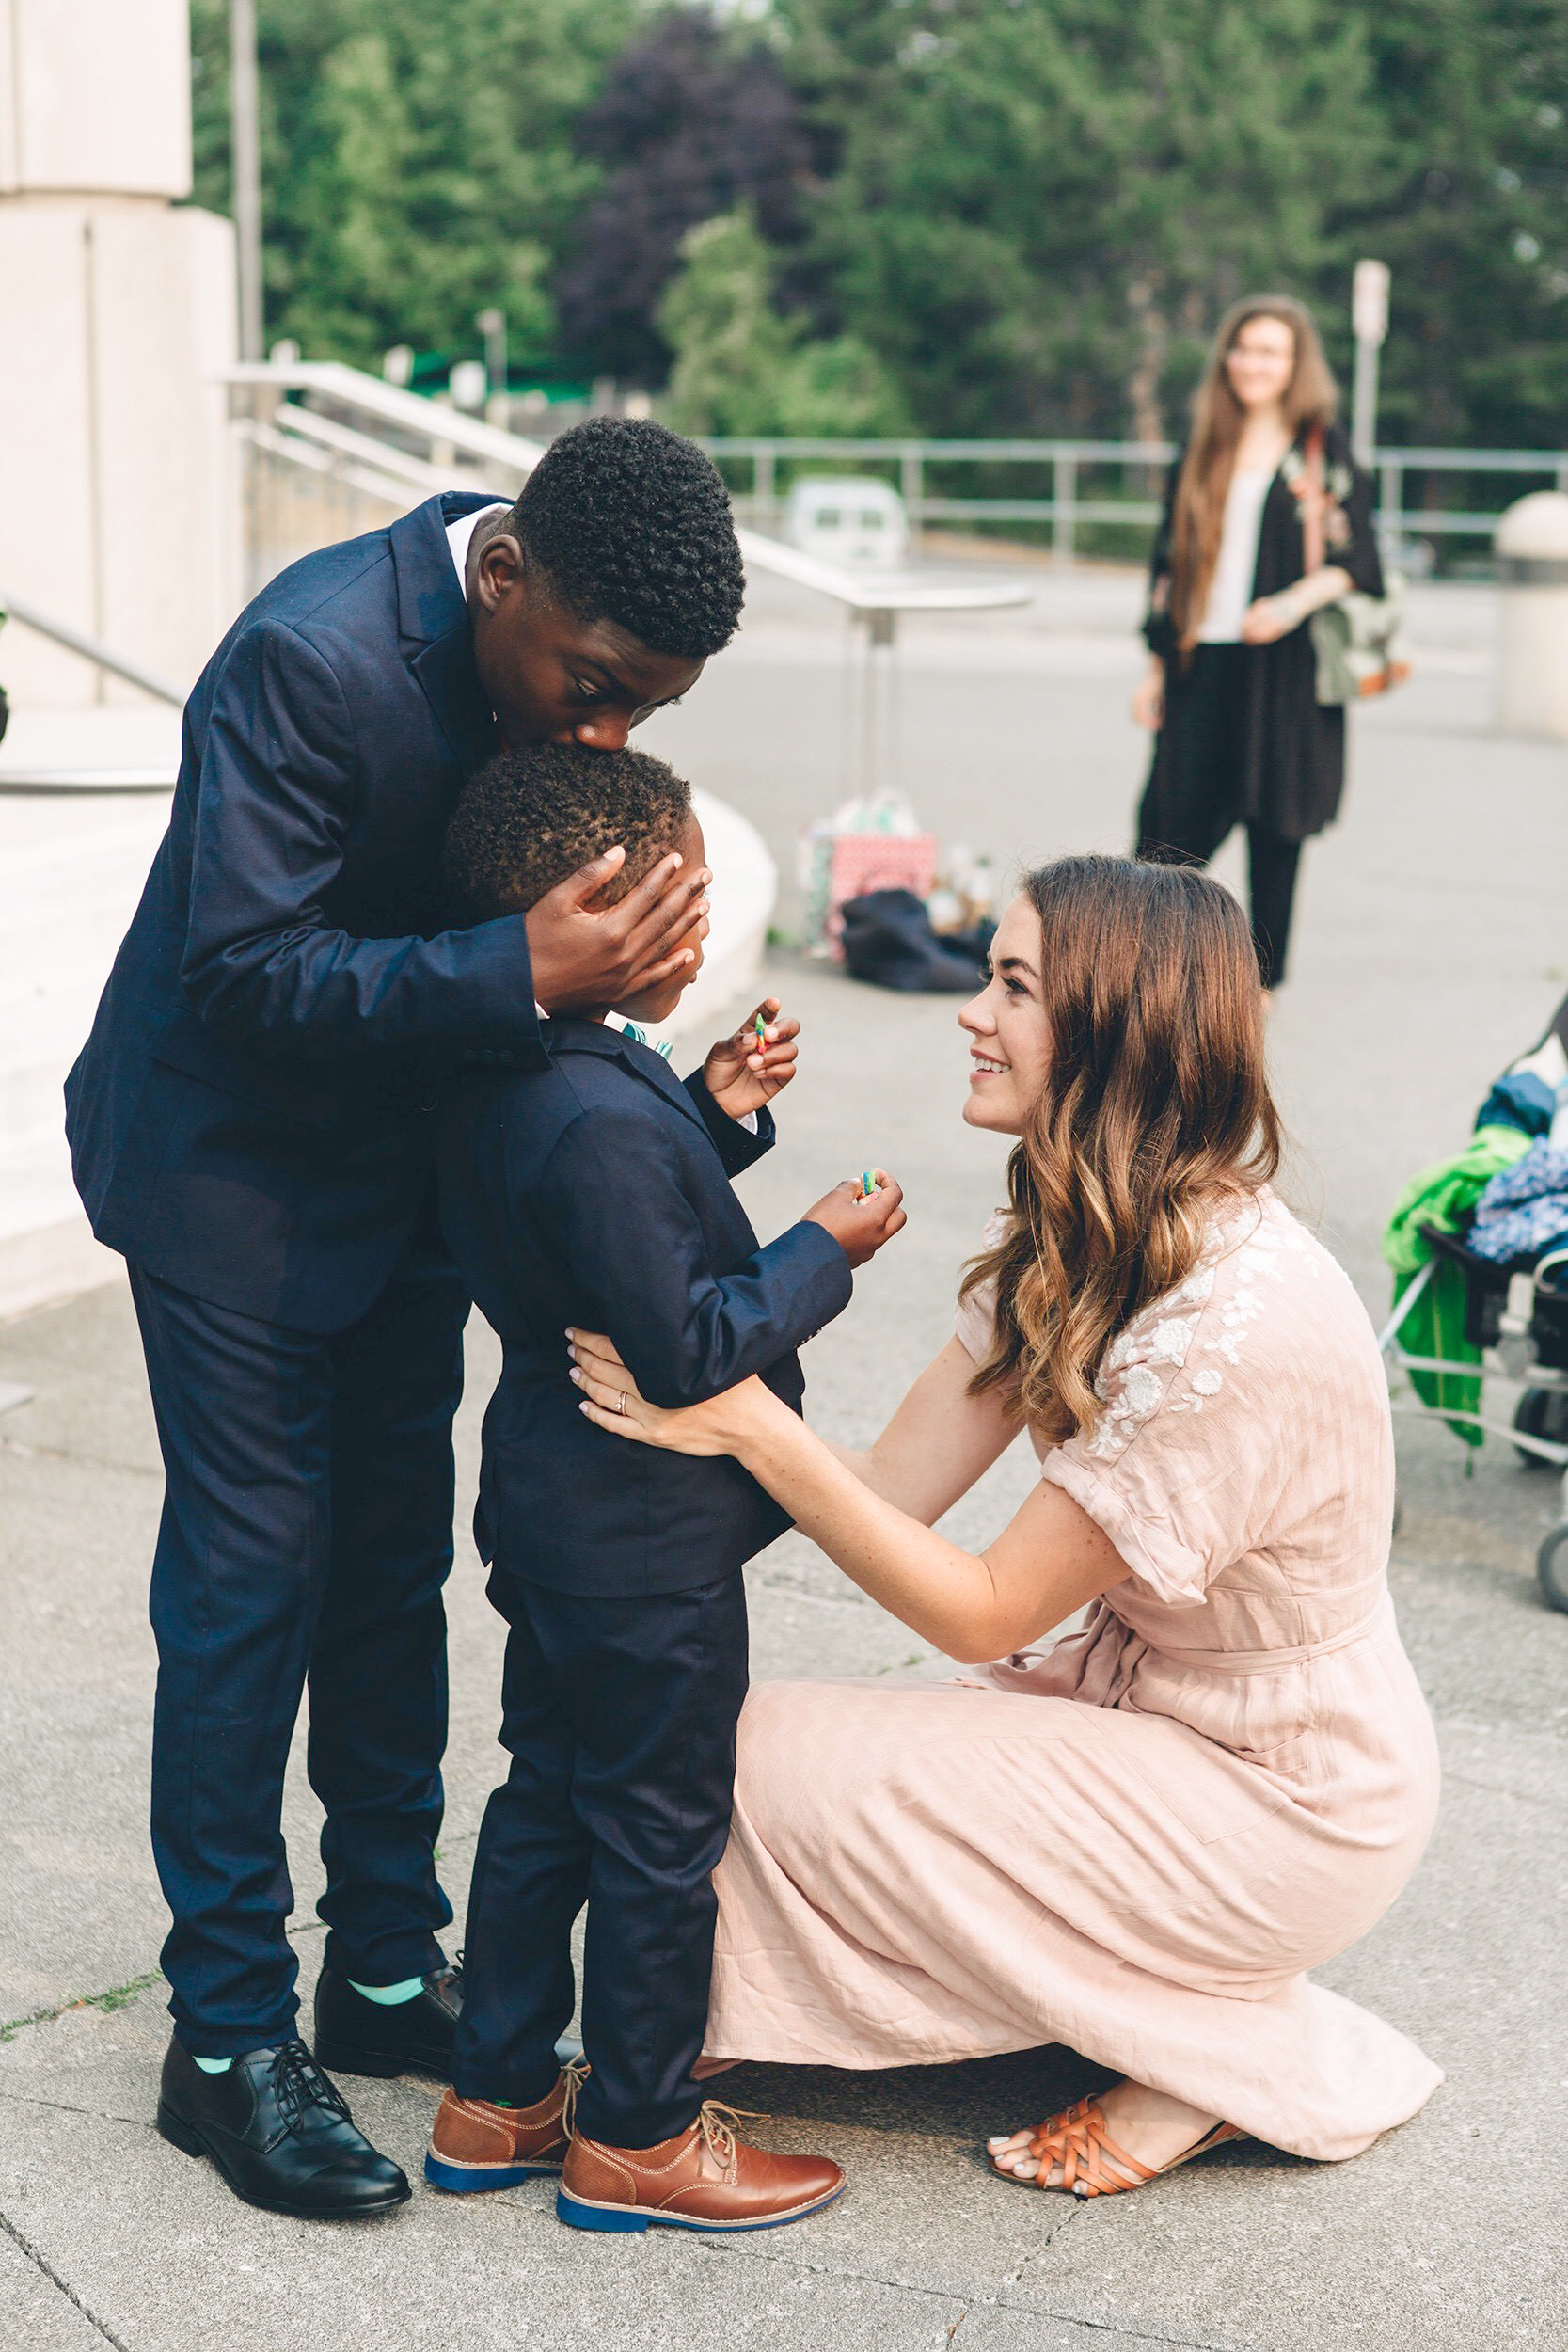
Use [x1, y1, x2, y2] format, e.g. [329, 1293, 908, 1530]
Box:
[961, 856, 1284, 1444]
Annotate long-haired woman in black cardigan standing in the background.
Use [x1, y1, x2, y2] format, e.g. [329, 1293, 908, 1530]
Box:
[1133, 294, 1383, 988]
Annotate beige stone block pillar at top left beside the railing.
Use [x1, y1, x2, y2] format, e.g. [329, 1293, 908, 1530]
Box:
[0, 0, 240, 706]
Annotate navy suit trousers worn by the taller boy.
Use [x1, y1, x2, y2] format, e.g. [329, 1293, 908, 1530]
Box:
[132, 1204, 467, 2058]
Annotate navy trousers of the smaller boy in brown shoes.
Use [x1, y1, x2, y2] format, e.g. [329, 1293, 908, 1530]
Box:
[451, 1569, 748, 2148]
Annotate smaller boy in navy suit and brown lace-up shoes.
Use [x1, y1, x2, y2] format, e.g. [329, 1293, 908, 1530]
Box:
[425, 746, 903, 2230]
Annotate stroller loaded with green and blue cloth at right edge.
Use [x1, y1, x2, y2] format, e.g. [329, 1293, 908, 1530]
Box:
[1378, 997, 1568, 1612]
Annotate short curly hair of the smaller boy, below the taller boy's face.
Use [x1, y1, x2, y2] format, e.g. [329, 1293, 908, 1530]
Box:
[442, 743, 691, 922]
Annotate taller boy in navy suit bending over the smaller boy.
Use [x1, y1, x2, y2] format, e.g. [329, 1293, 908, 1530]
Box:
[66, 419, 767, 2216]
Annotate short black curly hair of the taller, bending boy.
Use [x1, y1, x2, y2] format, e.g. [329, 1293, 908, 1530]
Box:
[510, 417, 745, 661]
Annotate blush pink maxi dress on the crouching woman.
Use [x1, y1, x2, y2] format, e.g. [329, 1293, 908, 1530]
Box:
[707, 1193, 1441, 2159]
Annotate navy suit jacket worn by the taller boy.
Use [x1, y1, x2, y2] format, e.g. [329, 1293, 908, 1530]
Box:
[66, 492, 768, 1334]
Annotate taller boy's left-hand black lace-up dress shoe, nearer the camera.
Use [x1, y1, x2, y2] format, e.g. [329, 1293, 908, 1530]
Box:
[157, 2037, 409, 2220]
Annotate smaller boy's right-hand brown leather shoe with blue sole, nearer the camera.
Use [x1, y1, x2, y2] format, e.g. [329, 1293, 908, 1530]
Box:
[555, 2098, 844, 2230]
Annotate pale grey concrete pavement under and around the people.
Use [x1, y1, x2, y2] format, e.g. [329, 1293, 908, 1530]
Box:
[0, 579, 1568, 2352]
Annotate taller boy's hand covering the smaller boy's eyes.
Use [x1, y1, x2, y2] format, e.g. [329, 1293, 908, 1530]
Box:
[524, 847, 712, 1014]
